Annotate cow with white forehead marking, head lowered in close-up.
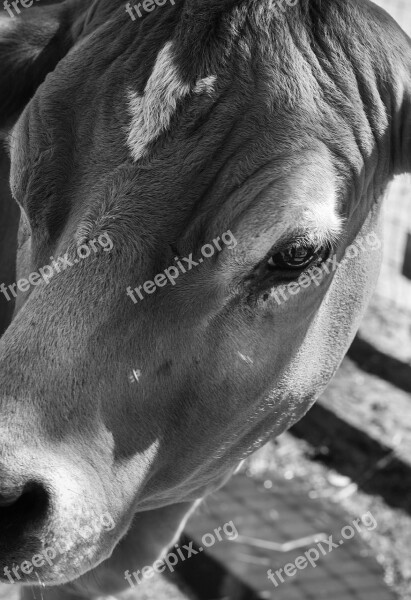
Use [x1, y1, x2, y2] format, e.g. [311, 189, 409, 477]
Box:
[0, 0, 411, 600]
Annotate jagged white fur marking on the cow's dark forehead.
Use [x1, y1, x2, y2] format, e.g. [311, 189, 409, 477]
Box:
[127, 42, 216, 161]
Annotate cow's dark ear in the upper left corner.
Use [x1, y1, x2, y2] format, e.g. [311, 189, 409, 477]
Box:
[0, 1, 73, 129]
